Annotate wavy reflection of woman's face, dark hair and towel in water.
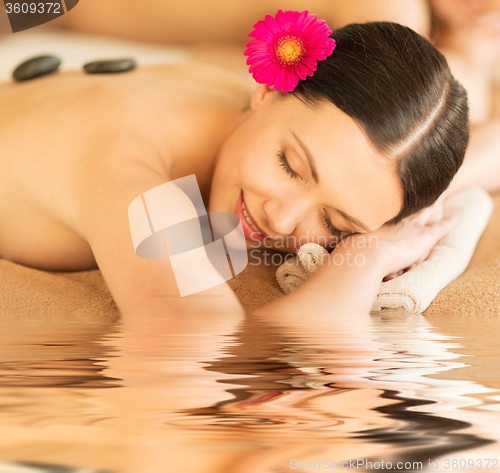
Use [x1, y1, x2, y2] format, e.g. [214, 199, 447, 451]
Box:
[171, 316, 493, 464]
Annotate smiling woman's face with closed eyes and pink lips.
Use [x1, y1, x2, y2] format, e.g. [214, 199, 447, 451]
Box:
[209, 85, 403, 253]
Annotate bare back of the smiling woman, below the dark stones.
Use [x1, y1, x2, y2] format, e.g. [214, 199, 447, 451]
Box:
[0, 61, 252, 271]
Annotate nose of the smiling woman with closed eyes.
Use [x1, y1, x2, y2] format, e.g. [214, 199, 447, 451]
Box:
[263, 196, 309, 235]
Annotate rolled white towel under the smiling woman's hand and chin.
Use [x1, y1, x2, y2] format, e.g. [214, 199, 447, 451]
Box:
[276, 187, 493, 314]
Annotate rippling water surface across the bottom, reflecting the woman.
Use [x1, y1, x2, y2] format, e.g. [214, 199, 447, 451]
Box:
[0, 314, 500, 473]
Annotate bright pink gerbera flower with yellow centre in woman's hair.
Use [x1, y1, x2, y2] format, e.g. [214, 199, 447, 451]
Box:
[245, 10, 335, 94]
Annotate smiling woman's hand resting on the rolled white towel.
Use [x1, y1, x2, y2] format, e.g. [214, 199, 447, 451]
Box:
[360, 196, 456, 280]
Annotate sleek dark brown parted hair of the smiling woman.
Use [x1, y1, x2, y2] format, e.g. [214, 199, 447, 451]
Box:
[287, 22, 469, 224]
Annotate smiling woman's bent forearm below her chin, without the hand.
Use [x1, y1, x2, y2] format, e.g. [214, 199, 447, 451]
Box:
[251, 243, 384, 342]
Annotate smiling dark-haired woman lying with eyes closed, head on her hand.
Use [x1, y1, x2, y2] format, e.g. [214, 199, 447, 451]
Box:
[0, 23, 468, 317]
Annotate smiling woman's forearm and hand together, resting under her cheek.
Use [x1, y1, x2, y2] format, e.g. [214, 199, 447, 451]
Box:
[253, 209, 454, 326]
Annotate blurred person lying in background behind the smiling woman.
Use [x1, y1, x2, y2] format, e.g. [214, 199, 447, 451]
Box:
[57, 0, 500, 195]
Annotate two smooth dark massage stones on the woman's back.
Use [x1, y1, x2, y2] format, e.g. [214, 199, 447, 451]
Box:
[12, 56, 137, 82]
